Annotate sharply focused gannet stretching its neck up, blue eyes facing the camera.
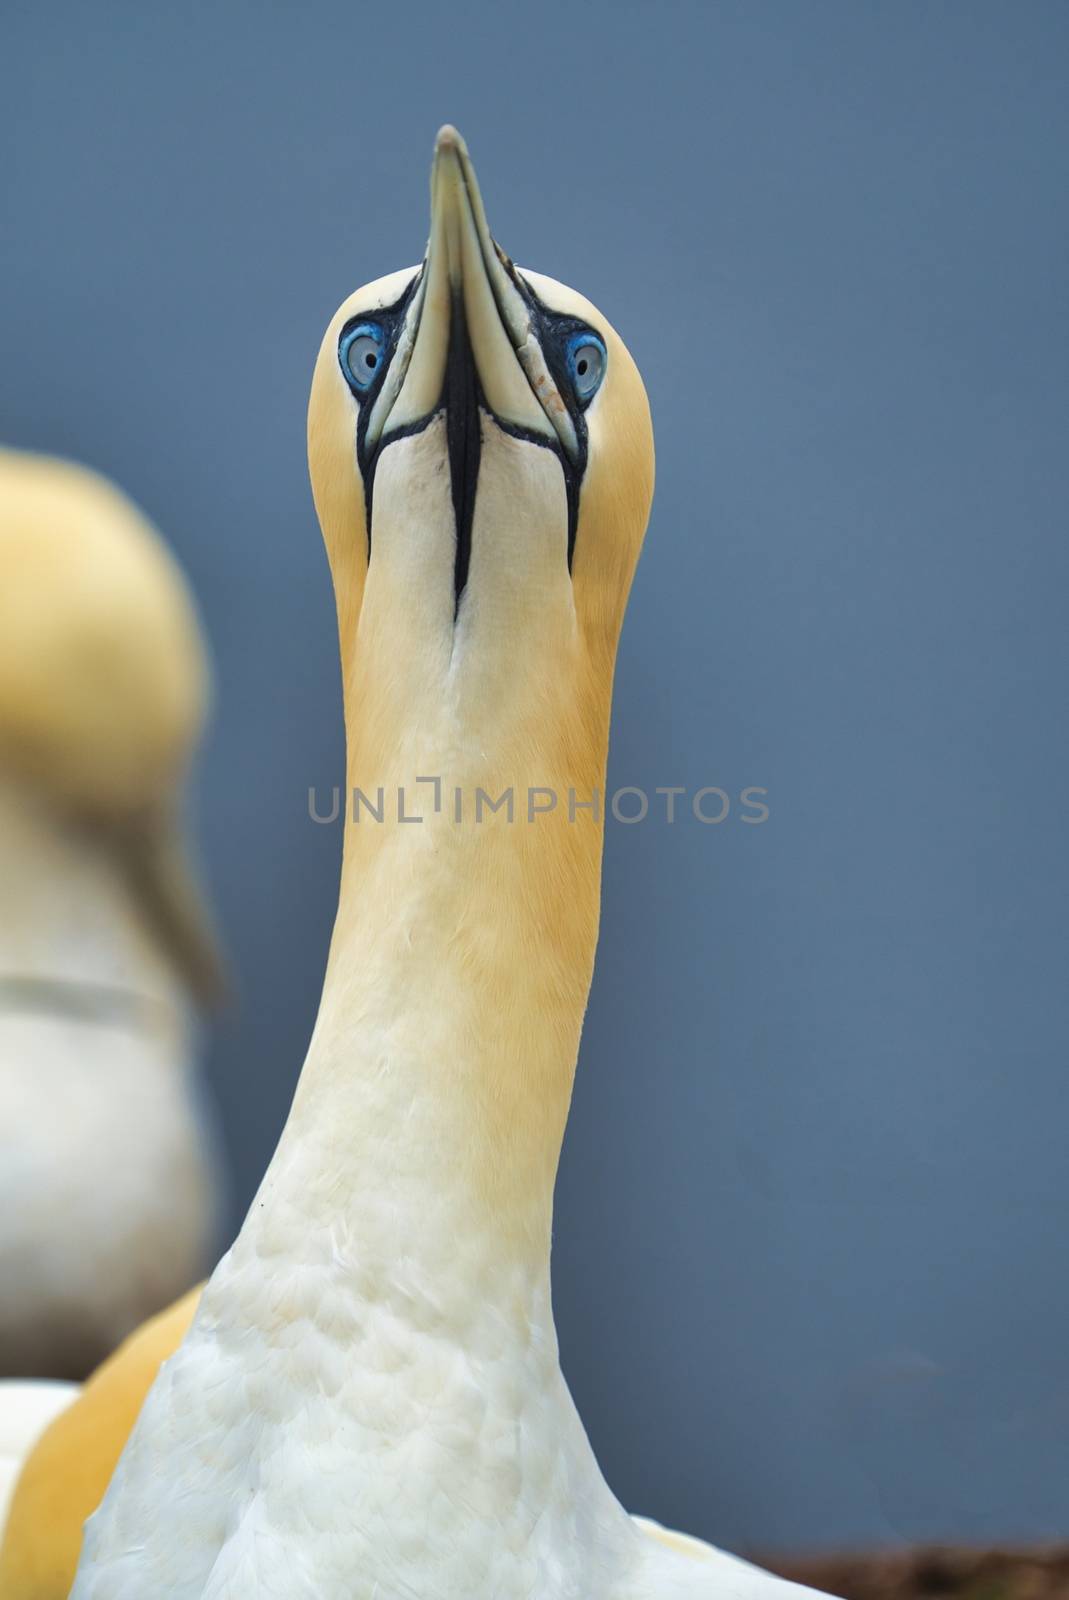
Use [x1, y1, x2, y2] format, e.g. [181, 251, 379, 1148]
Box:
[0, 126, 832, 1600]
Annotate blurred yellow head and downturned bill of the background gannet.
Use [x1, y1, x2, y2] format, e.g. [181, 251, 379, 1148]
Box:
[0, 450, 222, 998]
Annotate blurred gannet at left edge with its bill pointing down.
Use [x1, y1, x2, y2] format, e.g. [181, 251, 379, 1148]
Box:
[0, 450, 218, 1388]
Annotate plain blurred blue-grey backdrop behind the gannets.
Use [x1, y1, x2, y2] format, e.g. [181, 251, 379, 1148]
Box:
[0, 0, 1069, 1546]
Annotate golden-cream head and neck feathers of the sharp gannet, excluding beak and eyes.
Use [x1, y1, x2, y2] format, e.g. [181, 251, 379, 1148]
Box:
[296, 265, 653, 1273]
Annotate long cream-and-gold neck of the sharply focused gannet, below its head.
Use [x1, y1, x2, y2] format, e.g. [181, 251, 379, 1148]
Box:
[252, 662, 607, 1293]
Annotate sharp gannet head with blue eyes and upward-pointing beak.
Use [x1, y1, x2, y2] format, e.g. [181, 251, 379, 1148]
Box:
[309, 126, 653, 748]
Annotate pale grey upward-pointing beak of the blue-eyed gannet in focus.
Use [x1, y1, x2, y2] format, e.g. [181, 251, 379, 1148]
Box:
[366, 125, 578, 459]
